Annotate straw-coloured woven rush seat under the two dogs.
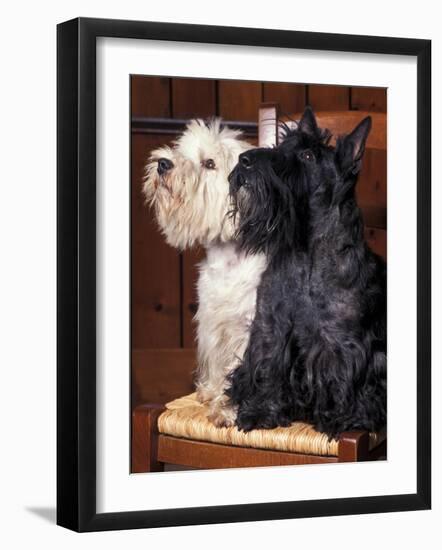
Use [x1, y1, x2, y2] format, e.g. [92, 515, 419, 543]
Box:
[158, 393, 385, 456]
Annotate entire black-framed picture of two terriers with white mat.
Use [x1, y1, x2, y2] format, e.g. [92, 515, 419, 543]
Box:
[57, 18, 431, 531]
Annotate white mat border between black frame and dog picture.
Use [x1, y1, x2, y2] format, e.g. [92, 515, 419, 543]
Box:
[97, 38, 416, 512]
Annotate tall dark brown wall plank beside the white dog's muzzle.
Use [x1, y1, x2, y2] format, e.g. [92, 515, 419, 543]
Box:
[131, 134, 181, 348]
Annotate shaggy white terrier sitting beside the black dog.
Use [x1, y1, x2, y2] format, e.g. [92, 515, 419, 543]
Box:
[143, 119, 266, 426]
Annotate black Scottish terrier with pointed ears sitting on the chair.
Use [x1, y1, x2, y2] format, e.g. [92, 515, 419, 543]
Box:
[227, 108, 386, 437]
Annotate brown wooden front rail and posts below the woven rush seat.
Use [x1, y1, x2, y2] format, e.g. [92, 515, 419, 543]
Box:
[131, 404, 386, 473]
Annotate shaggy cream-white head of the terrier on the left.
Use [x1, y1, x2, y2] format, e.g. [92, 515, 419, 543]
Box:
[143, 119, 252, 249]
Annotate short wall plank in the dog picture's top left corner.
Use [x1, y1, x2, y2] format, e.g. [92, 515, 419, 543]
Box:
[131, 75, 170, 117]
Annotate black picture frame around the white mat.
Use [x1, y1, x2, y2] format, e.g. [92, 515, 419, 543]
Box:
[57, 18, 431, 531]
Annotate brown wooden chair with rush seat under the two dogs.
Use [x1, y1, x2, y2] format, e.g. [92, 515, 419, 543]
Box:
[131, 104, 386, 473]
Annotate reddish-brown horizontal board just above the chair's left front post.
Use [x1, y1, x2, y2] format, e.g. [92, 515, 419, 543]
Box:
[132, 348, 196, 409]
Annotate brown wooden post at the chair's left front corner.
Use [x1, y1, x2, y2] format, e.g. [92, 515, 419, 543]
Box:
[131, 404, 165, 474]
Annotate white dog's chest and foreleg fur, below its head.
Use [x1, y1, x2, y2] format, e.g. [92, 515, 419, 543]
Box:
[196, 243, 266, 400]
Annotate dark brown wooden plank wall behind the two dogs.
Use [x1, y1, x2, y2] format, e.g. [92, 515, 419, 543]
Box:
[131, 76, 387, 405]
